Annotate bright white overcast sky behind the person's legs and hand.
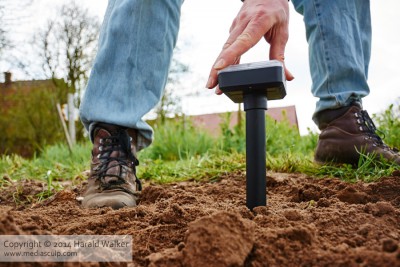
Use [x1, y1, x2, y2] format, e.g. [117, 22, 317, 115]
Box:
[0, 0, 400, 134]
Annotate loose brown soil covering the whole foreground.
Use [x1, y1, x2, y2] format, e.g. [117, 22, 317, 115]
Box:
[0, 173, 400, 267]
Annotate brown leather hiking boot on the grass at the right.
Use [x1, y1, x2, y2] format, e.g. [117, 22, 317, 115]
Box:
[315, 106, 400, 165]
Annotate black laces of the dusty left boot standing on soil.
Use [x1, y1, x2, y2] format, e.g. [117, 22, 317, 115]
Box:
[96, 132, 142, 191]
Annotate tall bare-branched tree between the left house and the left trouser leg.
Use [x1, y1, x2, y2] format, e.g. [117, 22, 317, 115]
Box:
[35, 1, 100, 141]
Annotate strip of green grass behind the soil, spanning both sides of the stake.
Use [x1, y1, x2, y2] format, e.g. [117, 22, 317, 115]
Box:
[0, 101, 400, 204]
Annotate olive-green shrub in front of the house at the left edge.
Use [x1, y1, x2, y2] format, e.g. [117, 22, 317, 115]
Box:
[0, 85, 64, 157]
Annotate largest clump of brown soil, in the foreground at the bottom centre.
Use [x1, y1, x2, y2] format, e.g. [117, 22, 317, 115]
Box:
[147, 211, 255, 267]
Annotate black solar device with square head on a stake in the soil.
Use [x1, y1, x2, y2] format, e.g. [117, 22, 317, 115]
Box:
[218, 60, 286, 210]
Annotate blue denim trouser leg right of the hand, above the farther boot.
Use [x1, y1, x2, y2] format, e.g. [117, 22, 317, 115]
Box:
[292, 0, 371, 125]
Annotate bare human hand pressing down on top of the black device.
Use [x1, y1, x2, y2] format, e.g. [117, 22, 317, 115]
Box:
[206, 0, 294, 95]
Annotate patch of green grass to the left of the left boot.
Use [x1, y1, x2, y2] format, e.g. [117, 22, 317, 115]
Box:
[0, 142, 91, 205]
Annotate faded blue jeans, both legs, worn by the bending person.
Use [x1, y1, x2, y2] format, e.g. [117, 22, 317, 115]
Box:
[80, 0, 371, 149]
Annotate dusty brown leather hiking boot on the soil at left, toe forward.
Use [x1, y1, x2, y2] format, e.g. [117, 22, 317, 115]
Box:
[82, 124, 141, 209]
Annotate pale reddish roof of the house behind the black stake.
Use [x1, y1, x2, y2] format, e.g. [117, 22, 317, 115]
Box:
[189, 106, 299, 136]
